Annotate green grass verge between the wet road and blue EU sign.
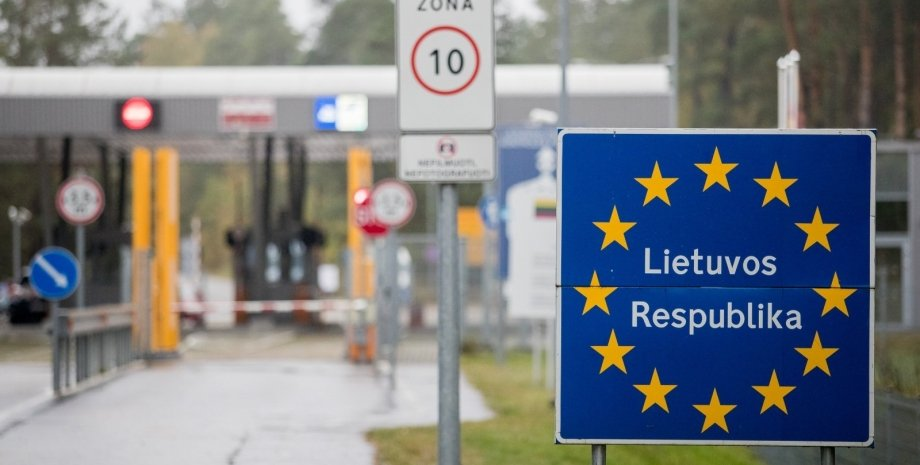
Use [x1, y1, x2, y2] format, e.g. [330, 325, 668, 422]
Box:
[368, 354, 761, 465]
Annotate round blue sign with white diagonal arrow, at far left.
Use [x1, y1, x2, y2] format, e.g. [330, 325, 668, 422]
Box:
[29, 247, 80, 300]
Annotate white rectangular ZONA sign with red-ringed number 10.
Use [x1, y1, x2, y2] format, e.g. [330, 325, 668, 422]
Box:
[396, 0, 495, 132]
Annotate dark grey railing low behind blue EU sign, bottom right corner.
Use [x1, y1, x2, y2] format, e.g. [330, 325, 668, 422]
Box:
[757, 392, 920, 465]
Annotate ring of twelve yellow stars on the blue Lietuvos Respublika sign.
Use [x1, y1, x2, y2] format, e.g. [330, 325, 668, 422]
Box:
[575, 147, 856, 434]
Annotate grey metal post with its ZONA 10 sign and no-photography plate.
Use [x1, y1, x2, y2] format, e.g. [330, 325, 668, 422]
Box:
[396, 0, 495, 465]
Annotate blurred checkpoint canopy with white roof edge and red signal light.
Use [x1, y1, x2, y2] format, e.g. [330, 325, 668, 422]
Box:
[0, 64, 669, 352]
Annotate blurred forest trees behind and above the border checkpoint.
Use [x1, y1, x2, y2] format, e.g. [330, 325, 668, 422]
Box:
[0, 0, 920, 273]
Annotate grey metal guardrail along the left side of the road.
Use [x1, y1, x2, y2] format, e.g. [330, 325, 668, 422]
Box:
[51, 304, 136, 396]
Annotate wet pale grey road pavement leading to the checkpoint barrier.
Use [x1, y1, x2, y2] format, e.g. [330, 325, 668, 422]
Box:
[0, 359, 491, 465]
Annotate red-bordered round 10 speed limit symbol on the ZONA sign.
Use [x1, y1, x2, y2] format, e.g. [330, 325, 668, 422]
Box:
[411, 26, 481, 95]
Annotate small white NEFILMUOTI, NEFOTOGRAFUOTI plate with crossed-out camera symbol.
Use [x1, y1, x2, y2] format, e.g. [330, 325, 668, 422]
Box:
[399, 134, 495, 182]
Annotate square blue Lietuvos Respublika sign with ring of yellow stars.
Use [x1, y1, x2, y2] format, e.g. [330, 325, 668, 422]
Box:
[556, 129, 875, 446]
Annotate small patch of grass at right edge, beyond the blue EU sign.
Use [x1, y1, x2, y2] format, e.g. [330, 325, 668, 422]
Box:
[875, 332, 920, 398]
